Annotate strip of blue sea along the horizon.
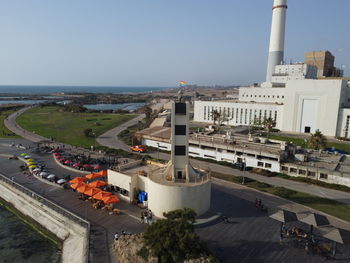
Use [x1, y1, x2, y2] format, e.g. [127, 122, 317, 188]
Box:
[0, 85, 173, 95]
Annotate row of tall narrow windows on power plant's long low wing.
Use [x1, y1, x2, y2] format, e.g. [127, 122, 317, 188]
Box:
[203, 106, 278, 125]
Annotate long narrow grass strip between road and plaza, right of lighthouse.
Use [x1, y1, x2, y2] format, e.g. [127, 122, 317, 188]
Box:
[212, 172, 350, 222]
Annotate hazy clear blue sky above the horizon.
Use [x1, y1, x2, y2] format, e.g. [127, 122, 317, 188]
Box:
[0, 0, 350, 86]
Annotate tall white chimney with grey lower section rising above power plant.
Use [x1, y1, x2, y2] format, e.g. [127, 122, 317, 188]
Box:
[266, 0, 288, 82]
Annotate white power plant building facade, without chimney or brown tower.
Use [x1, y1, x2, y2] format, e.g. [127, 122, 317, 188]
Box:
[194, 64, 350, 138]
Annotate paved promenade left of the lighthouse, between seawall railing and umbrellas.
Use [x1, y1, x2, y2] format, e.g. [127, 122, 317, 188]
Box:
[0, 139, 146, 263]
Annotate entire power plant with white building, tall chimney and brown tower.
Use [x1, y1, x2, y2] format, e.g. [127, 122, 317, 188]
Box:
[194, 0, 350, 138]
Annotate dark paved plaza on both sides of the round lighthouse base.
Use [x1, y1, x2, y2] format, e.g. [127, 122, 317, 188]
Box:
[0, 140, 350, 262]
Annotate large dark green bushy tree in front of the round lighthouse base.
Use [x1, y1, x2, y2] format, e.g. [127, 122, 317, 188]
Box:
[142, 208, 209, 263]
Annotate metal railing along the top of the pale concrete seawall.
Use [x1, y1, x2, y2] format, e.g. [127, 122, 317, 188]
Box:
[0, 174, 90, 262]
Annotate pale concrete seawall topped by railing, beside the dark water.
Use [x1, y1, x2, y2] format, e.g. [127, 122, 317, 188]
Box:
[0, 174, 90, 263]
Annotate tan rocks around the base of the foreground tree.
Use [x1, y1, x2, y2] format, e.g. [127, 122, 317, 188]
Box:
[113, 234, 217, 263]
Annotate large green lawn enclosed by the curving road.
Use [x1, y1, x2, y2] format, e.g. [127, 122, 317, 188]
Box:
[17, 106, 136, 148]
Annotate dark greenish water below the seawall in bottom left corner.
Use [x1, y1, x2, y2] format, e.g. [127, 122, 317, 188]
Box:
[0, 205, 61, 263]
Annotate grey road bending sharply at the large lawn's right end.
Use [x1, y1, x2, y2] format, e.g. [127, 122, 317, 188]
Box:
[97, 114, 146, 151]
